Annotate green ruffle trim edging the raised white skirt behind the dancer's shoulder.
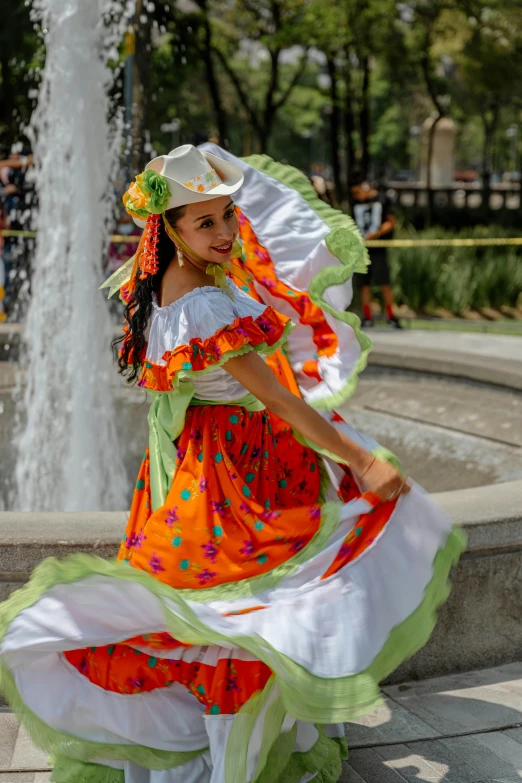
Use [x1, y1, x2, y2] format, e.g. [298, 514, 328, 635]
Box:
[243, 155, 372, 410]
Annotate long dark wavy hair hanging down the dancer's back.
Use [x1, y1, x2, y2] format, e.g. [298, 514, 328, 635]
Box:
[112, 206, 186, 383]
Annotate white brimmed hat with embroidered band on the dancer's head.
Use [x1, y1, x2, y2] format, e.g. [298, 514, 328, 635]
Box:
[133, 144, 244, 227]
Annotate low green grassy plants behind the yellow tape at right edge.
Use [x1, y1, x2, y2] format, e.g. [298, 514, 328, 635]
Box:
[388, 226, 522, 315]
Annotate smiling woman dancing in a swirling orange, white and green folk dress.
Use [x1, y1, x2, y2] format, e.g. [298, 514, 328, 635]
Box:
[0, 145, 463, 783]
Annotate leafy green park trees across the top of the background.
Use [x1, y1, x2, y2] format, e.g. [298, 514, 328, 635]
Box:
[0, 0, 522, 178]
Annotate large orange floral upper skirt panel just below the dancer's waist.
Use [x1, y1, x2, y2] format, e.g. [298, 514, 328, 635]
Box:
[123, 405, 321, 589]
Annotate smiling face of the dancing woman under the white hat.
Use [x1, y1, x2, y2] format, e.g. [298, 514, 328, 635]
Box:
[176, 196, 239, 264]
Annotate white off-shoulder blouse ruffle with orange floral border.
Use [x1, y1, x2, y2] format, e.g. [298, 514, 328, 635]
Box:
[138, 283, 293, 391]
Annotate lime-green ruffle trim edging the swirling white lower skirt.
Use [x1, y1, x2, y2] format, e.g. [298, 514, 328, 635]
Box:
[0, 526, 466, 756]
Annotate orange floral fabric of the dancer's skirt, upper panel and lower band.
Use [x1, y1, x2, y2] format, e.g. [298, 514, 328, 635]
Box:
[65, 405, 359, 714]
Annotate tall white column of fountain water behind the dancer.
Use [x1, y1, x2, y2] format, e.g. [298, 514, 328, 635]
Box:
[15, 0, 132, 511]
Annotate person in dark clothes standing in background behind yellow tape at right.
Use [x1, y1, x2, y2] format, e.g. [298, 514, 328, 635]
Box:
[351, 171, 402, 329]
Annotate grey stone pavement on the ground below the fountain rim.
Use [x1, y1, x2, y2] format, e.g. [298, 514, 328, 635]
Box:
[0, 663, 522, 783]
